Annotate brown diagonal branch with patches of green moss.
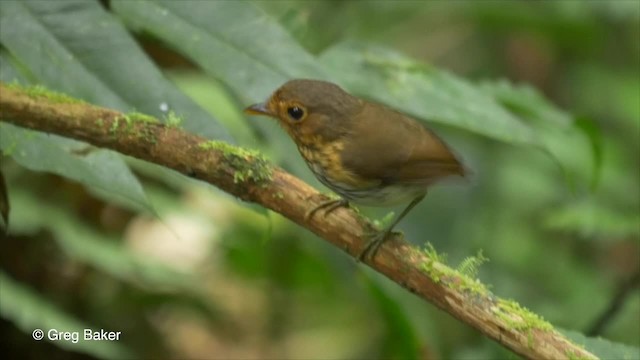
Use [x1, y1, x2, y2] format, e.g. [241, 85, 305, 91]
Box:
[0, 84, 596, 360]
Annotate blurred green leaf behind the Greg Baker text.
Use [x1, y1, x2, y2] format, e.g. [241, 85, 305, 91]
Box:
[0, 271, 133, 359]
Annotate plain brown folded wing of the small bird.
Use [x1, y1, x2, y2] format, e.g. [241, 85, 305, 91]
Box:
[342, 103, 464, 185]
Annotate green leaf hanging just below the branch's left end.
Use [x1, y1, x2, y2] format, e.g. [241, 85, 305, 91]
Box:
[0, 123, 153, 212]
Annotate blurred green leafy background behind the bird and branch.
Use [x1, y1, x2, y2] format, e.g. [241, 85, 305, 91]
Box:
[0, 0, 640, 359]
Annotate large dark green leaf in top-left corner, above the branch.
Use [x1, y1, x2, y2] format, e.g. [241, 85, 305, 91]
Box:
[0, 0, 232, 141]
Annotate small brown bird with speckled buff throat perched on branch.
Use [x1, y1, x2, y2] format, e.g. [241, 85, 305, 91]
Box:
[245, 79, 465, 260]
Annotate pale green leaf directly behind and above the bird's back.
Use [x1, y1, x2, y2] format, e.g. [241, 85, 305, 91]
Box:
[321, 42, 540, 145]
